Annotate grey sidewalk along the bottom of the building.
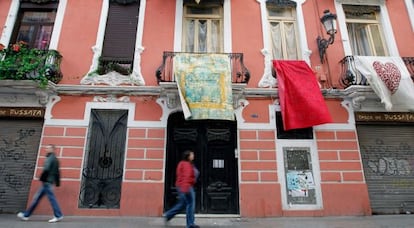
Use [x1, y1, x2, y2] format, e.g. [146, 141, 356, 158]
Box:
[0, 214, 414, 228]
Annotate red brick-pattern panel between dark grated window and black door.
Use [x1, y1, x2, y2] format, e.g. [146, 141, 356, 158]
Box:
[124, 128, 165, 182]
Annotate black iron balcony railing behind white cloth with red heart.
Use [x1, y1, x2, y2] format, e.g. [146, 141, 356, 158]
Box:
[339, 55, 414, 88]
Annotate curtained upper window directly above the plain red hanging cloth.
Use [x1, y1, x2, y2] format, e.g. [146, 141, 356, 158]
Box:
[267, 4, 300, 59]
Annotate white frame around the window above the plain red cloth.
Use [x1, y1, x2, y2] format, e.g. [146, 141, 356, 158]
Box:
[256, 0, 312, 88]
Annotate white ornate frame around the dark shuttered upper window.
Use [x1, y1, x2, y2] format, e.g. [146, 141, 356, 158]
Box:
[81, 0, 147, 86]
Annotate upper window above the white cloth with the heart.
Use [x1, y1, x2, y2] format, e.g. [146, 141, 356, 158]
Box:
[343, 5, 388, 56]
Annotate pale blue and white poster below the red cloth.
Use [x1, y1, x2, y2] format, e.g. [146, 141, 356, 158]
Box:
[286, 171, 315, 197]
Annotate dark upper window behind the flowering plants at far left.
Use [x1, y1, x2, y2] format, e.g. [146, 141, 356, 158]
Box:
[10, 1, 58, 49]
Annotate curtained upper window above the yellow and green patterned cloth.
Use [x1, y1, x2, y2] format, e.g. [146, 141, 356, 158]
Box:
[182, 2, 223, 52]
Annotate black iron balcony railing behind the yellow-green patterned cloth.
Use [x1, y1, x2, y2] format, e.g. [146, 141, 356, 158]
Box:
[155, 52, 250, 84]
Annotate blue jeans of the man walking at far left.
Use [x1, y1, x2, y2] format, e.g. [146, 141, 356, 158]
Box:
[24, 183, 63, 218]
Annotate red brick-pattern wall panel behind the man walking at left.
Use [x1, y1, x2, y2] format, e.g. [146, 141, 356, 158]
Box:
[36, 126, 87, 181]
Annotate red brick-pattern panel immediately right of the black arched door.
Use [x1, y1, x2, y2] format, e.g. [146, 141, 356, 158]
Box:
[239, 130, 278, 183]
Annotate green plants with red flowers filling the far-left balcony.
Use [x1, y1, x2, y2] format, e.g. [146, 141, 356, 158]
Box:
[0, 41, 62, 88]
